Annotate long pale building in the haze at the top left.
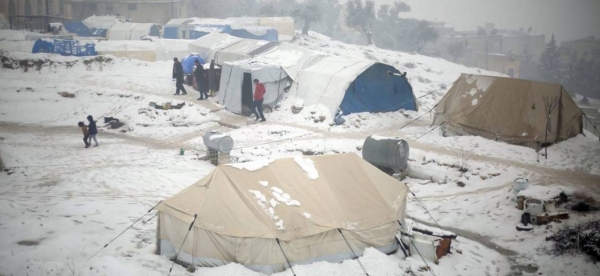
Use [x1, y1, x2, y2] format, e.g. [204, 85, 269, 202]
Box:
[72, 0, 187, 25]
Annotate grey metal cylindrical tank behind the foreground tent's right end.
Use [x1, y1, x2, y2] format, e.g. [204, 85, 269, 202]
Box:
[363, 135, 409, 172]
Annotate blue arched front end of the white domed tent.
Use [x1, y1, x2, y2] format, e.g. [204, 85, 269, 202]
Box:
[340, 63, 417, 114]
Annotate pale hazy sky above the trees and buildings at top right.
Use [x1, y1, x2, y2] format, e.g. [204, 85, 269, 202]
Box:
[375, 0, 600, 41]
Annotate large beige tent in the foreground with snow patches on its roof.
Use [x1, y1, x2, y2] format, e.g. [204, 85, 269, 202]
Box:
[157, 154, 407, 274]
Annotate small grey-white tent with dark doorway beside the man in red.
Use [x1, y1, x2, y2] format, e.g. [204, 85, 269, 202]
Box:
[217, 60, 288, 114]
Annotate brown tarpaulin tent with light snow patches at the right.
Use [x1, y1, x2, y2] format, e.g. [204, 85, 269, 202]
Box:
[433, 74, 583, 150]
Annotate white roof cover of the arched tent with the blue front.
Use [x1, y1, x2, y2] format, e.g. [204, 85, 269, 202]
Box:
[285, 56, 375, 115]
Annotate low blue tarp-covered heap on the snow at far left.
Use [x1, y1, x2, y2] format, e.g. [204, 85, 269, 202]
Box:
[31, 39, 97, 57]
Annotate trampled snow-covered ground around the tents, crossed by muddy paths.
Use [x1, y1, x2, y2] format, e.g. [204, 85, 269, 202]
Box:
[0, 31, 600, 276]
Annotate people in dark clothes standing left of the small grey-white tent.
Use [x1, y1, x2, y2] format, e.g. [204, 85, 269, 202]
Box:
[173, 58, 215, 101]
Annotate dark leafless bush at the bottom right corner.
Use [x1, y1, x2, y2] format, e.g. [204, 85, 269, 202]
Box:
[546, 220, 600, 263]
